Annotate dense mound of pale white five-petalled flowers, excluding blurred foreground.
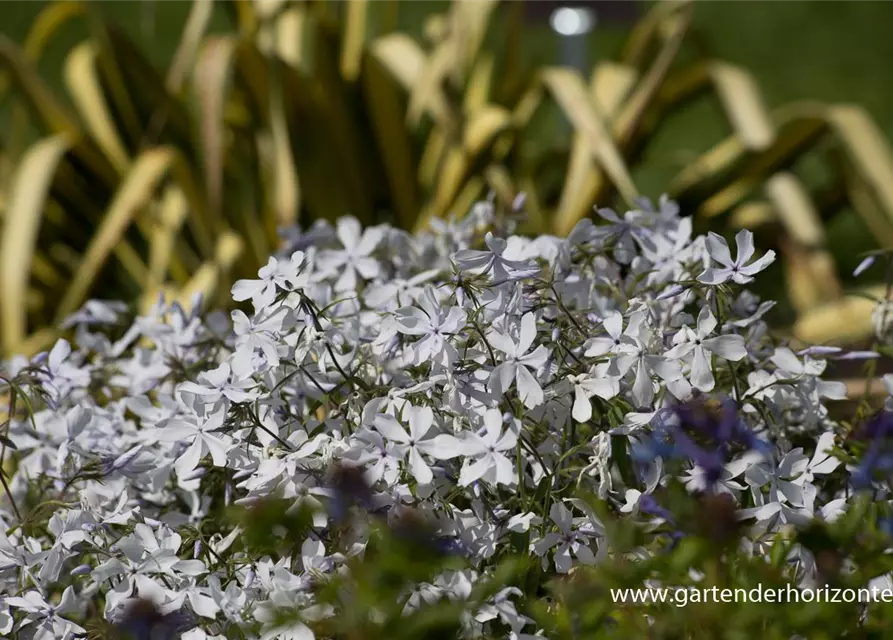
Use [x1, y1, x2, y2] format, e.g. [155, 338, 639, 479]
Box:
[0, 200, 876, 640]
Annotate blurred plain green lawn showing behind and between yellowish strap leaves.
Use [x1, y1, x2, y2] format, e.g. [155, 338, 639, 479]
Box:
[0, 0, 893, 310]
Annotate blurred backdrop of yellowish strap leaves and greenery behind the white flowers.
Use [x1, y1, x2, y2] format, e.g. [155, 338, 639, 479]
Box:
[0, 0, 893, 351]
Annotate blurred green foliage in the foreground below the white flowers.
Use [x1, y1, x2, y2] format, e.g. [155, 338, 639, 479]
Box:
[233, 481, 893, 640]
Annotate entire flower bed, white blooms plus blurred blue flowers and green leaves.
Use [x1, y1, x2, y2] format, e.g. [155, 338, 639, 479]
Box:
[0, 200, 893, 640]
